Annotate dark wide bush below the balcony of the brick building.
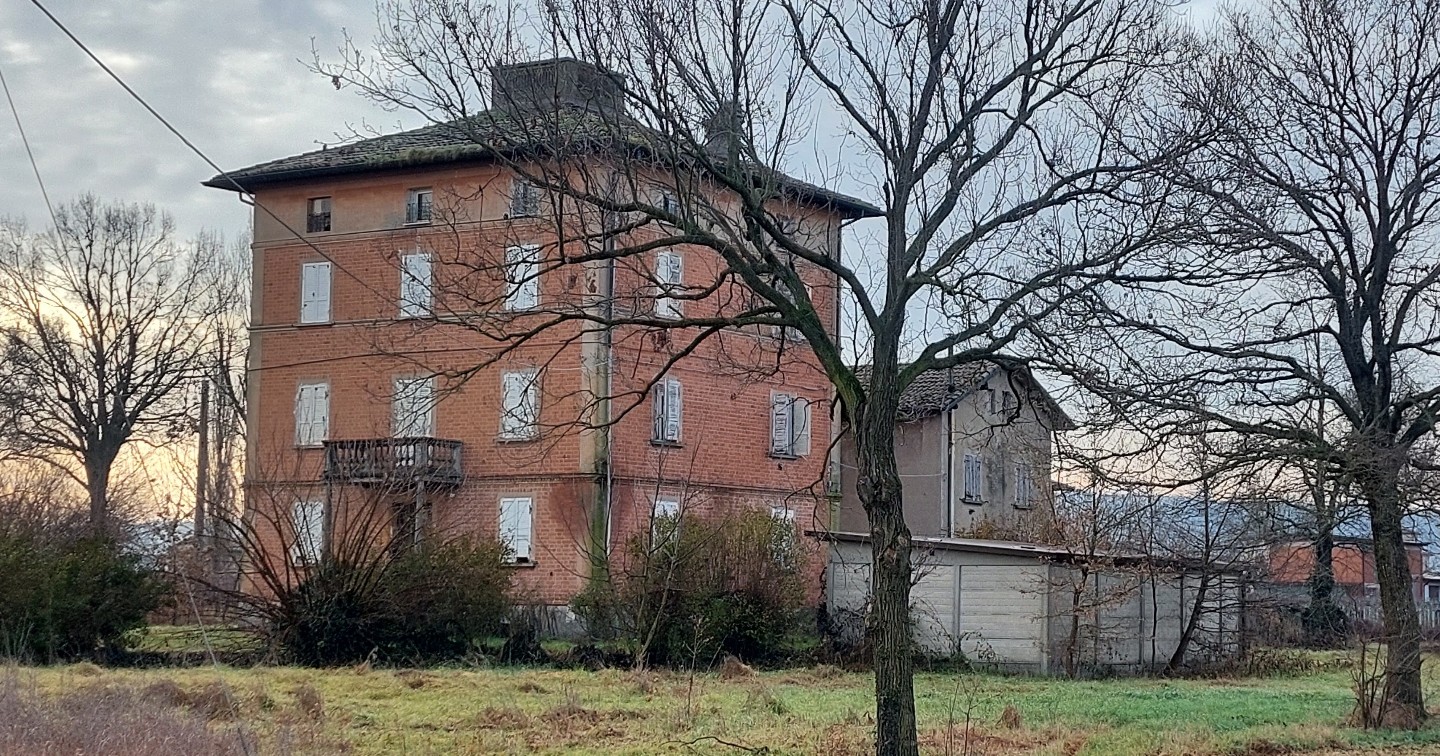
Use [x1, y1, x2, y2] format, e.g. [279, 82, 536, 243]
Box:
[269, 540, 510, 665]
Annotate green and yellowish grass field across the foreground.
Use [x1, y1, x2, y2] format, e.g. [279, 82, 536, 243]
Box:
[8, 658, 1440, 755]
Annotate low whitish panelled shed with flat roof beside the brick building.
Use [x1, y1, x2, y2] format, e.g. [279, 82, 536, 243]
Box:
[824, 533, 1244, 674]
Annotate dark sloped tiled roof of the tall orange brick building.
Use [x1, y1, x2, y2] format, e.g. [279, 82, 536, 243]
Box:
[203, 108, 883, 217]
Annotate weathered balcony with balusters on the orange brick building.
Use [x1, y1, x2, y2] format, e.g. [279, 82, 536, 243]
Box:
[325, 438, 464, 487]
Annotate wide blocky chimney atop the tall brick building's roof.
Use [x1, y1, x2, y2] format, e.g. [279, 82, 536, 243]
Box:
[490, 58, 625, 115]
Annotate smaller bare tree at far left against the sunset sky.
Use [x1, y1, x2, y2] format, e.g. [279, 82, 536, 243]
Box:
[0, 196, 225, 531]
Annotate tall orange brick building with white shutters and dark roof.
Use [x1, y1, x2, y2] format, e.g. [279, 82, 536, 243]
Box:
[207, 54, 874, 619]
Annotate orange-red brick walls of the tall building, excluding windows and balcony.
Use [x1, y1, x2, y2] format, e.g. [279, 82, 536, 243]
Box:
[234, 163, 840, 605]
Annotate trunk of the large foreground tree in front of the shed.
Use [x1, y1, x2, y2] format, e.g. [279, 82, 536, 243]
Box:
[851, 360, 919, 756]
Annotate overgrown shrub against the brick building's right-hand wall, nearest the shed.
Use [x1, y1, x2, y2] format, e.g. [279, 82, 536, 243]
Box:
[573, 511, 809, 667]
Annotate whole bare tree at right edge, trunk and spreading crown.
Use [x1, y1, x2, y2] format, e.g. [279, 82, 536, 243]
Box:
[1096, 0, 1440, 726]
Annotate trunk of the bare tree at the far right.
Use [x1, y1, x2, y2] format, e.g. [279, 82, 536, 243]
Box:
[1358, 465, 1427, 727]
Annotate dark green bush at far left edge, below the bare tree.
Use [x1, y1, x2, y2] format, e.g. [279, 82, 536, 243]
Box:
[0, 528, 167, 661]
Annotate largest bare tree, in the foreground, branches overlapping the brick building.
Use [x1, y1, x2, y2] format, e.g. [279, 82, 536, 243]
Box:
[317, 0, 1182, 755]
